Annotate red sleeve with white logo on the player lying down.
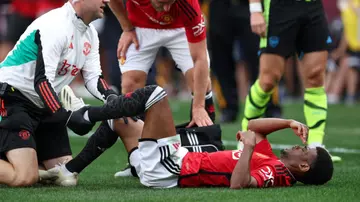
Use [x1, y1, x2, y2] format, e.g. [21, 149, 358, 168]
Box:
[250, 165, 275, 188]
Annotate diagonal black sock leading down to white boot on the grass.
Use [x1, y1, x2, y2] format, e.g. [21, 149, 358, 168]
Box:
[65, 121, 118, 173]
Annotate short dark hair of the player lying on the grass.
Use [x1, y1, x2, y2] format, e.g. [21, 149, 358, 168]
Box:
[299, 147, 334, 185]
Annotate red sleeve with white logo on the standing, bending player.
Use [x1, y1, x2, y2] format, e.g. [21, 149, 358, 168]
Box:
[178, 0, 206, 43]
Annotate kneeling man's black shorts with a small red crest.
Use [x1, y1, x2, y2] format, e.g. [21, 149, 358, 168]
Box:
[0, 84, 71, 162]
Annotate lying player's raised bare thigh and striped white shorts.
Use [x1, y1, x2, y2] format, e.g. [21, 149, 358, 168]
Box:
[129, 94, 188, 188]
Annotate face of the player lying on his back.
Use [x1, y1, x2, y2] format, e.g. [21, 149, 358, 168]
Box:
[281, 145, 317, 164]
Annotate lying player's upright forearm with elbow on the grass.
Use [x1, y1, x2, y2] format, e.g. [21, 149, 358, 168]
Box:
[230, 131, 257, 189]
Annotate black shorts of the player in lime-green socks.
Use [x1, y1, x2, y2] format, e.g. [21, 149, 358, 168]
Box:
[260, 0, 331, 58]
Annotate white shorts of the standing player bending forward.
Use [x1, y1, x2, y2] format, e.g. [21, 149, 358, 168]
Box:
[119, 27, 210, 74]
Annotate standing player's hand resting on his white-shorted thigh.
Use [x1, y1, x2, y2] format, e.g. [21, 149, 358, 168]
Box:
[117, 29, 139, 65]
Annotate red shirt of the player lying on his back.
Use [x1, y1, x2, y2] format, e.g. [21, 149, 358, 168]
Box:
[179, 139, 295, 187]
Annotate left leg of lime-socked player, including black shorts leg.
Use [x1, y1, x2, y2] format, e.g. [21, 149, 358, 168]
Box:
[241, 1, 299, 130]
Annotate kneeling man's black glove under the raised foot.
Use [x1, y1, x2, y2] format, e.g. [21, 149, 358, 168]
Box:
[67, 106, 95, 135]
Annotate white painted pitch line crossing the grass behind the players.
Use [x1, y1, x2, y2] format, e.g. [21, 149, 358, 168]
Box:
[68, 130, 360, 154]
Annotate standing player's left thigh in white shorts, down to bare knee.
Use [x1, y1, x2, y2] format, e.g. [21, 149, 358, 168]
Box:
[119, 27, 161, 94]
